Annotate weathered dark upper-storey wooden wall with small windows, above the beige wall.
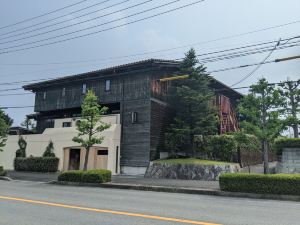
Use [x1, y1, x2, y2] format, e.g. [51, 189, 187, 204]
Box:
[35, 75, 150, 112]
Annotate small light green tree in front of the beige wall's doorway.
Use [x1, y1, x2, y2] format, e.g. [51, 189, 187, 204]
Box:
[73, 90, 110, 170]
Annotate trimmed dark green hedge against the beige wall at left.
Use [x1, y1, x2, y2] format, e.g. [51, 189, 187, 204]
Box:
[14, 157, 59, 173]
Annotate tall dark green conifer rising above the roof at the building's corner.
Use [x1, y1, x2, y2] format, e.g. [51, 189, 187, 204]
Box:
[166, 49, 218, 154]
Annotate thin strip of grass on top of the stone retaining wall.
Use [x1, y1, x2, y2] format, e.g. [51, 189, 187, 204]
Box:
[153, 158, 235, 166]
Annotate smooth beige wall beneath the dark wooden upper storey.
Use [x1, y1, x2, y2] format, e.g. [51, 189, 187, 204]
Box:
[0, 115, 121, 174]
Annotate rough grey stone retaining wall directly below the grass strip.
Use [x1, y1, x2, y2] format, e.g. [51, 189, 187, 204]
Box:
[145, 162, 240, 181]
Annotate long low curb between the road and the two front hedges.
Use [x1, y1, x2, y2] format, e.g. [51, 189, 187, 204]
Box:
[49, 181, 300, 202]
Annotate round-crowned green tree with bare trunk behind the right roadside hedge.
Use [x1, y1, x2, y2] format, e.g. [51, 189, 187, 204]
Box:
[238, 78, 283, 174]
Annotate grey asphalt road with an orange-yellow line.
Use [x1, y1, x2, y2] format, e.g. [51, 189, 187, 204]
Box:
[0, 181, 300, 225]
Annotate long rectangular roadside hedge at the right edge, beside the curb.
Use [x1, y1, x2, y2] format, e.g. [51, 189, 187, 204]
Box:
[219, 173, 300, 195]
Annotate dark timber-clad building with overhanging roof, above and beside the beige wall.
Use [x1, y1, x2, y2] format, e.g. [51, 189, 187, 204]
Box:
[24, 59, 241, 167]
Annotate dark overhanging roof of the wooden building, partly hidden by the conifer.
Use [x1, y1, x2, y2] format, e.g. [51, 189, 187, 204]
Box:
[23, 59, 242, 99]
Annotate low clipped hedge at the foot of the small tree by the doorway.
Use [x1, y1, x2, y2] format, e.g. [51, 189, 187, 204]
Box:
[58, 170, 111, 183]
